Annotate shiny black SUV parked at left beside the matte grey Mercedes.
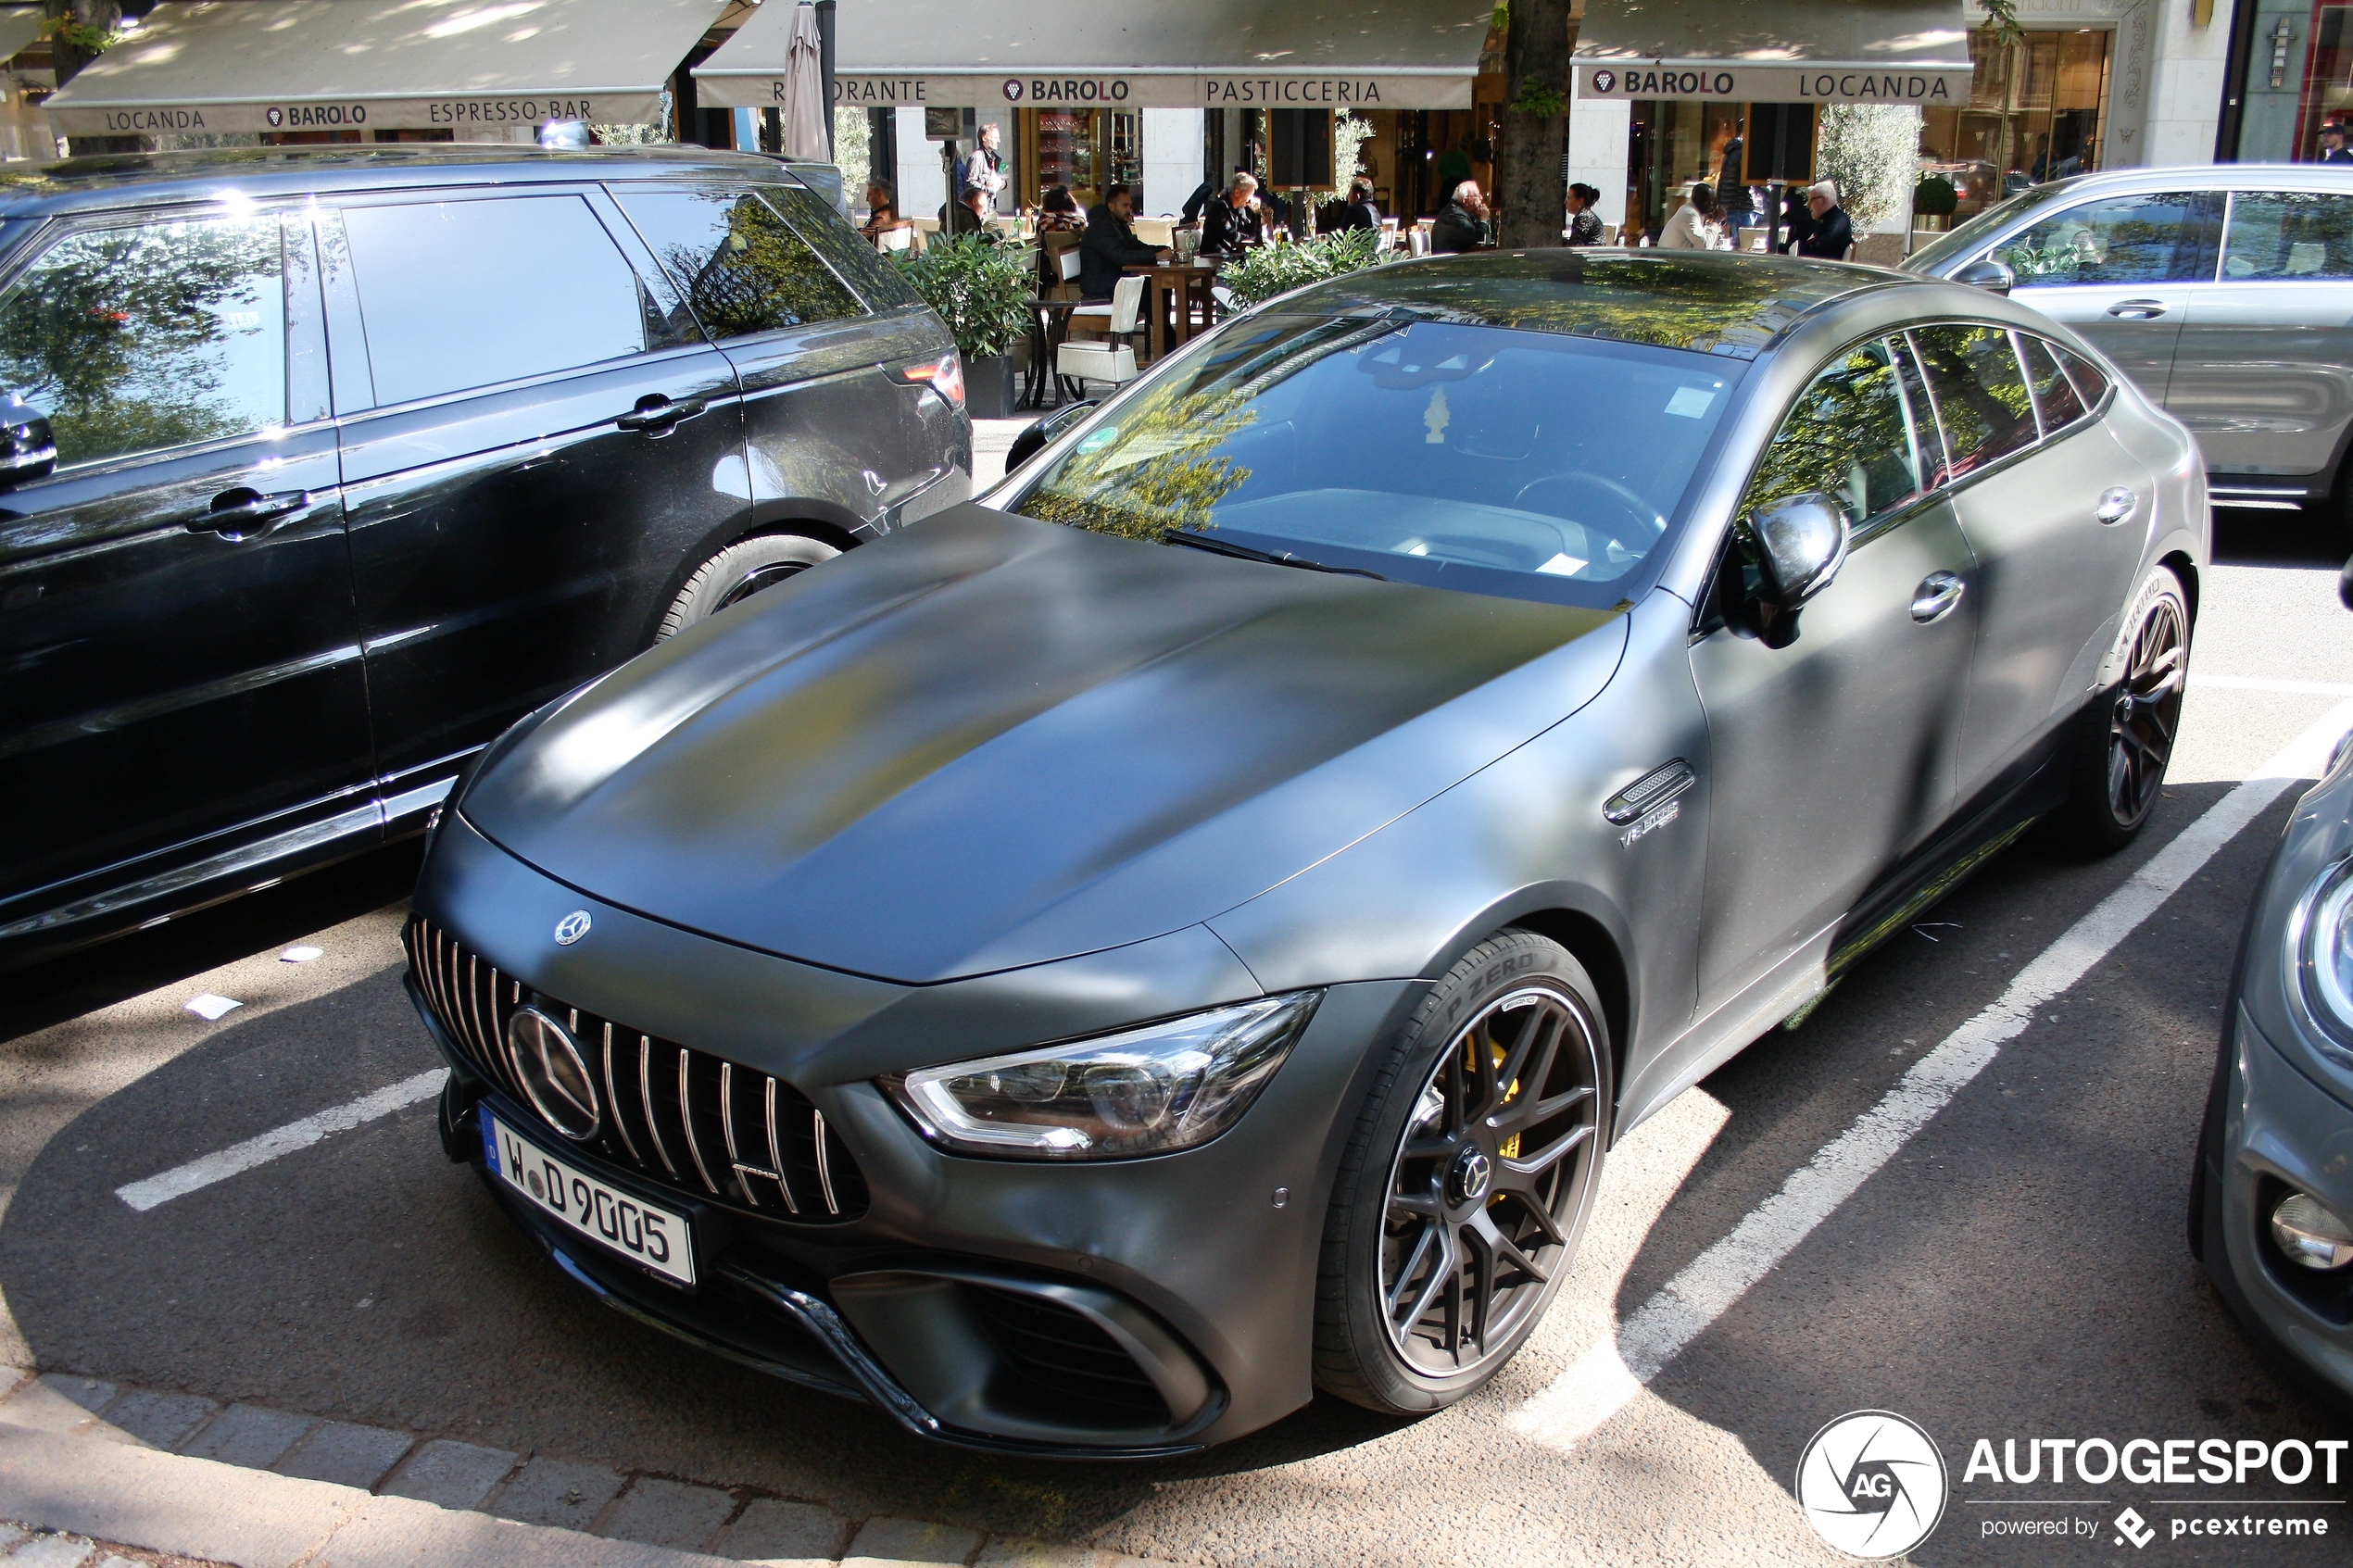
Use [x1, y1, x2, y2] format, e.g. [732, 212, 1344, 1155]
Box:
[0, 145, 972, 961]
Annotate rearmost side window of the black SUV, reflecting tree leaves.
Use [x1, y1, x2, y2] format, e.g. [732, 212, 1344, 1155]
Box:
[611, 186, 862, 339]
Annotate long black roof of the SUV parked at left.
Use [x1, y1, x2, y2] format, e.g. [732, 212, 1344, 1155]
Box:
[0, 144, 809, 219]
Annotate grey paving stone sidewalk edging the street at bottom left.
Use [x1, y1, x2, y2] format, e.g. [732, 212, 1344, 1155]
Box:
[0, 1373, 1149, 1568]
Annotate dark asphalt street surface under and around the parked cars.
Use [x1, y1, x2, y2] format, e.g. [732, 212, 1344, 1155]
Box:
[0, 512, 2353, 1568]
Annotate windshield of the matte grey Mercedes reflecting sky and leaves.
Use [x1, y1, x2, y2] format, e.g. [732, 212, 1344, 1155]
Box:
[1014, 315, 1746, 607]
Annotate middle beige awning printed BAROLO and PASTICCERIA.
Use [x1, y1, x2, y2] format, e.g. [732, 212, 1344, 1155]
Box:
[694, 0, 1494, 108]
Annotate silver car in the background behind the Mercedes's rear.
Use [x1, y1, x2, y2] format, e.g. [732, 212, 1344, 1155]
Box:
[1904, 165, 2353, 521]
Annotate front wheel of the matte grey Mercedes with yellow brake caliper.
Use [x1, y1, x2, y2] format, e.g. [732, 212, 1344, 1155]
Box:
[1315, 931, 1614, 1415]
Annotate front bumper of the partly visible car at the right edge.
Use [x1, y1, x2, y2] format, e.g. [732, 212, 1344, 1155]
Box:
[2208, 1006, 2353, 1399]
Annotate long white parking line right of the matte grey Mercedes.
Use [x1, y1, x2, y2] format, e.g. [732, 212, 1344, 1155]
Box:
[1511, 703, 2353, 1453]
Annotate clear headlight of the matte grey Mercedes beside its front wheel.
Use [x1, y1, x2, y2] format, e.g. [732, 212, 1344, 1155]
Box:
[883, 992, 1322, 1159]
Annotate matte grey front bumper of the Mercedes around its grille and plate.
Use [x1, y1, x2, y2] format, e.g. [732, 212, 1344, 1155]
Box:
[409, 813, 1421, 1458]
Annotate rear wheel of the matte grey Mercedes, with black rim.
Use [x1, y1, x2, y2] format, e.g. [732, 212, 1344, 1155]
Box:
[2045, 567, 2191, 856]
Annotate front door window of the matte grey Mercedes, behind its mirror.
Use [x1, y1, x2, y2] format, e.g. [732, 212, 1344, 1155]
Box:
[1742, 341, 1936, 524]
